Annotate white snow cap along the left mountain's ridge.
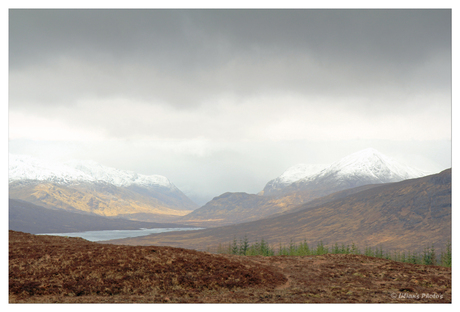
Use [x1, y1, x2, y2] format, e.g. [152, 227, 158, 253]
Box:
[8, 154, 176, 190]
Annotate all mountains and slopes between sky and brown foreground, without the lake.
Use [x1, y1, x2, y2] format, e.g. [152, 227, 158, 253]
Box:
[9, 148, 452, 251]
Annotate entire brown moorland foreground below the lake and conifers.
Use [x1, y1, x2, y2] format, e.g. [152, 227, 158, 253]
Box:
[9, 231, 452, 303]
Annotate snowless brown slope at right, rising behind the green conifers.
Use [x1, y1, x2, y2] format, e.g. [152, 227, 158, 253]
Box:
[107, 169, 452, 251]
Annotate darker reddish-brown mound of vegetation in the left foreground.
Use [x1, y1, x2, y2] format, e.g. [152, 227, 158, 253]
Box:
[9, 231, 286, 302]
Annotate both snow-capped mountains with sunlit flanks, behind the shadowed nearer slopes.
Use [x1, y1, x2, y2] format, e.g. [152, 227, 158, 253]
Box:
[9, 149, 442, 235]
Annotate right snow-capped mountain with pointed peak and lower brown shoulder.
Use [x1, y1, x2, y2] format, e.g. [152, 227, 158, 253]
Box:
[180, 148, 428, 226]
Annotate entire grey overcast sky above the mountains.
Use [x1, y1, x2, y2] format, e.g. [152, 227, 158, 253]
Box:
[8, 9, 452, 204]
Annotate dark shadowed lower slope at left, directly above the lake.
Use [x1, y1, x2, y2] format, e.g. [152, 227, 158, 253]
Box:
[8, 199, 196, 234]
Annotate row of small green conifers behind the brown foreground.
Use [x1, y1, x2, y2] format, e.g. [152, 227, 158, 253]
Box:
[217, 236, 452, 267]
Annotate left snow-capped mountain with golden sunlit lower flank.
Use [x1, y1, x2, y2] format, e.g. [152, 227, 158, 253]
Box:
[8, 154, 198, 222]
